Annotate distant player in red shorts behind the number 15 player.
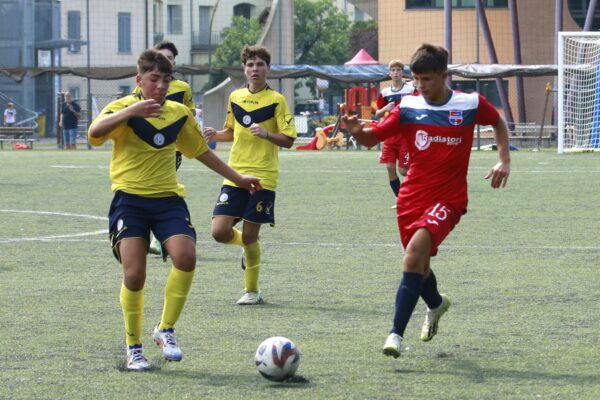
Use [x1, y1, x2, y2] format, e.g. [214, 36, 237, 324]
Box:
[375, 60, 417, 208]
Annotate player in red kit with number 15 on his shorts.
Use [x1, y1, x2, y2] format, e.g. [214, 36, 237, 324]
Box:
[344, 44, 510, 357]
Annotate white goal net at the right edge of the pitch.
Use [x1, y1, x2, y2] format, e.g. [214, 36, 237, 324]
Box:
[558, 32, 600, 154]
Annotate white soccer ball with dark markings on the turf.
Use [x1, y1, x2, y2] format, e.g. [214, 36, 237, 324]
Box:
[254, 336, 300, 381]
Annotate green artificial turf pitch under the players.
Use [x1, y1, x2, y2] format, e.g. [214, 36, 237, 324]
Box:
[0, 147, 600, 399]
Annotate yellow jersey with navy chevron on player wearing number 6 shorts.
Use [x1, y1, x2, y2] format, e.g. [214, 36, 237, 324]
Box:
[223, 87, 296, 191]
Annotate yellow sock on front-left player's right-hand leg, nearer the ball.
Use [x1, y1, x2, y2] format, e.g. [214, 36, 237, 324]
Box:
[158, 265, 194, 329]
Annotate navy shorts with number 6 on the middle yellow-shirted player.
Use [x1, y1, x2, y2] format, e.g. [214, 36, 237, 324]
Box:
[213, 185, 275, 226]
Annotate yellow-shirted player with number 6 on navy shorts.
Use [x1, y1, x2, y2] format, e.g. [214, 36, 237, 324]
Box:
[204, 46, 296, 305]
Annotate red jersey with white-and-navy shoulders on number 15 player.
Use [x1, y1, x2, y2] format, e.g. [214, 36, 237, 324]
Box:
[373, 92, 500, 214]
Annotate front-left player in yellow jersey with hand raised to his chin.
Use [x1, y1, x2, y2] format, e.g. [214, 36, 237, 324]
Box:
[88, 49, 261, 370]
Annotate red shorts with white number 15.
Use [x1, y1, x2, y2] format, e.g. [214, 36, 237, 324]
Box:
[398, 203, 462, 257]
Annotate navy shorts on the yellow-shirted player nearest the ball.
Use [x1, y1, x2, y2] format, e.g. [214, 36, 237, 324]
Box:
[108, 191, 196, 262]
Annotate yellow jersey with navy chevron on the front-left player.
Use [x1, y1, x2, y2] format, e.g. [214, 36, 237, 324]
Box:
[88, 95, 208, 197]
